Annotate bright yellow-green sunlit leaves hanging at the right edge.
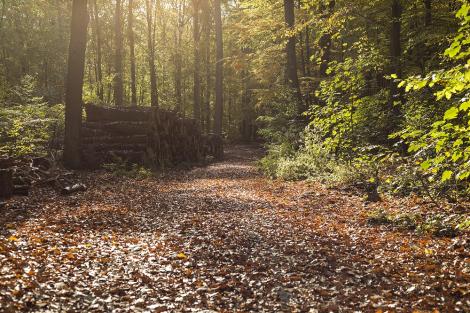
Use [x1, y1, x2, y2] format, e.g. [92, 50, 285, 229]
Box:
[395, 3, 470, 192]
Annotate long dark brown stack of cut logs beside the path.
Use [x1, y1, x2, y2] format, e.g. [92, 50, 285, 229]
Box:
[81, 104, 223, 168]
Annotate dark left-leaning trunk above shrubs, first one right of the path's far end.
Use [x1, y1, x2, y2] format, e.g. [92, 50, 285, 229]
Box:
[284, 0, 304, 115]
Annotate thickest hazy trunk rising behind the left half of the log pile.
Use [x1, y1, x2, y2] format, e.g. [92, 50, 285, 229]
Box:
[114, 0, 124, 106]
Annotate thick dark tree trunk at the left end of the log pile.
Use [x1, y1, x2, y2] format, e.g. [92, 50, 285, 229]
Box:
[64, 0, 89, 168]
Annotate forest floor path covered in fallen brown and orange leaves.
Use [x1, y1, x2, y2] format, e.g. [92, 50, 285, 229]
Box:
[0, 146, 470, 313]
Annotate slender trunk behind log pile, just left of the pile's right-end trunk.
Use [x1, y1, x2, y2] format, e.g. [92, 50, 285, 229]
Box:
[193, 0, 201, 122]
